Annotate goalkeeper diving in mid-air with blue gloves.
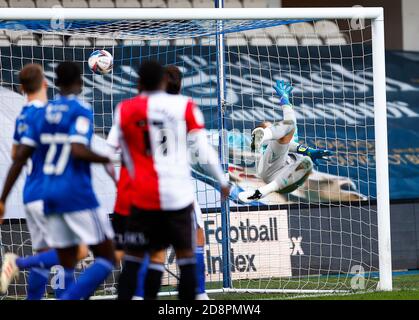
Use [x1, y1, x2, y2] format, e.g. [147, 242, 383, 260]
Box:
[239, 80, 333, 203]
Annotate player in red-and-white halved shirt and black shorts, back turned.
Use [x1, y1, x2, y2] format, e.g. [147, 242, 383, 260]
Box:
[115, 61, 229, 300]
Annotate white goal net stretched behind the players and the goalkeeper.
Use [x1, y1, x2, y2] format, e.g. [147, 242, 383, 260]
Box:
[0, 9, 391, 298]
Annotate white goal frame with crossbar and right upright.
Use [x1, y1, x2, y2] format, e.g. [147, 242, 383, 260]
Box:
[0, 7, 392, 293]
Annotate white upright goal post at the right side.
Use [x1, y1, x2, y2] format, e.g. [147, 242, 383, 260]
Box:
[372, 12, 393, 291]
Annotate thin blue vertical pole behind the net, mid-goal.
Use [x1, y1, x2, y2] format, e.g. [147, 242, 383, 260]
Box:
[215, 0, 232, 288]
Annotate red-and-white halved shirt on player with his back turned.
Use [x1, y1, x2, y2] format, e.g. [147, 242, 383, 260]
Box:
[115, 91, 204, 210]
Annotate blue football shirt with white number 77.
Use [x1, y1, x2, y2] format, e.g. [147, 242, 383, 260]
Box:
[27, 95, 99, 214]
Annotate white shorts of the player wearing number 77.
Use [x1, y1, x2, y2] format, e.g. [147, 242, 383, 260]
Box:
[46, 208, 114, 249]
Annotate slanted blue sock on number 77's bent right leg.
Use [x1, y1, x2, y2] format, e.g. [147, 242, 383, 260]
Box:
[60, 258, 113, 300]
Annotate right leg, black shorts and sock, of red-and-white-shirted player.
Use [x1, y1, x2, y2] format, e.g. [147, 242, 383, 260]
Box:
[168, 205, 197, 301]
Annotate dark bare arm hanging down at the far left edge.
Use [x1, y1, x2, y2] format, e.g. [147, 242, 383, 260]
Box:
[0, 144, 35, 223]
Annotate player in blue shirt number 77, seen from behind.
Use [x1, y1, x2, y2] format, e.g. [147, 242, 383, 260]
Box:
[17, 62, 114, 300]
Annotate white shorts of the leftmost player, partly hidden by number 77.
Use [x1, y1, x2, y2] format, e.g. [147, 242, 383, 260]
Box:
[25, 200, 48, 251]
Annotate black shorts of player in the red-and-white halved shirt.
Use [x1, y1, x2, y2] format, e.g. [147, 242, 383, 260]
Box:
[125, 205, 195, 251]
